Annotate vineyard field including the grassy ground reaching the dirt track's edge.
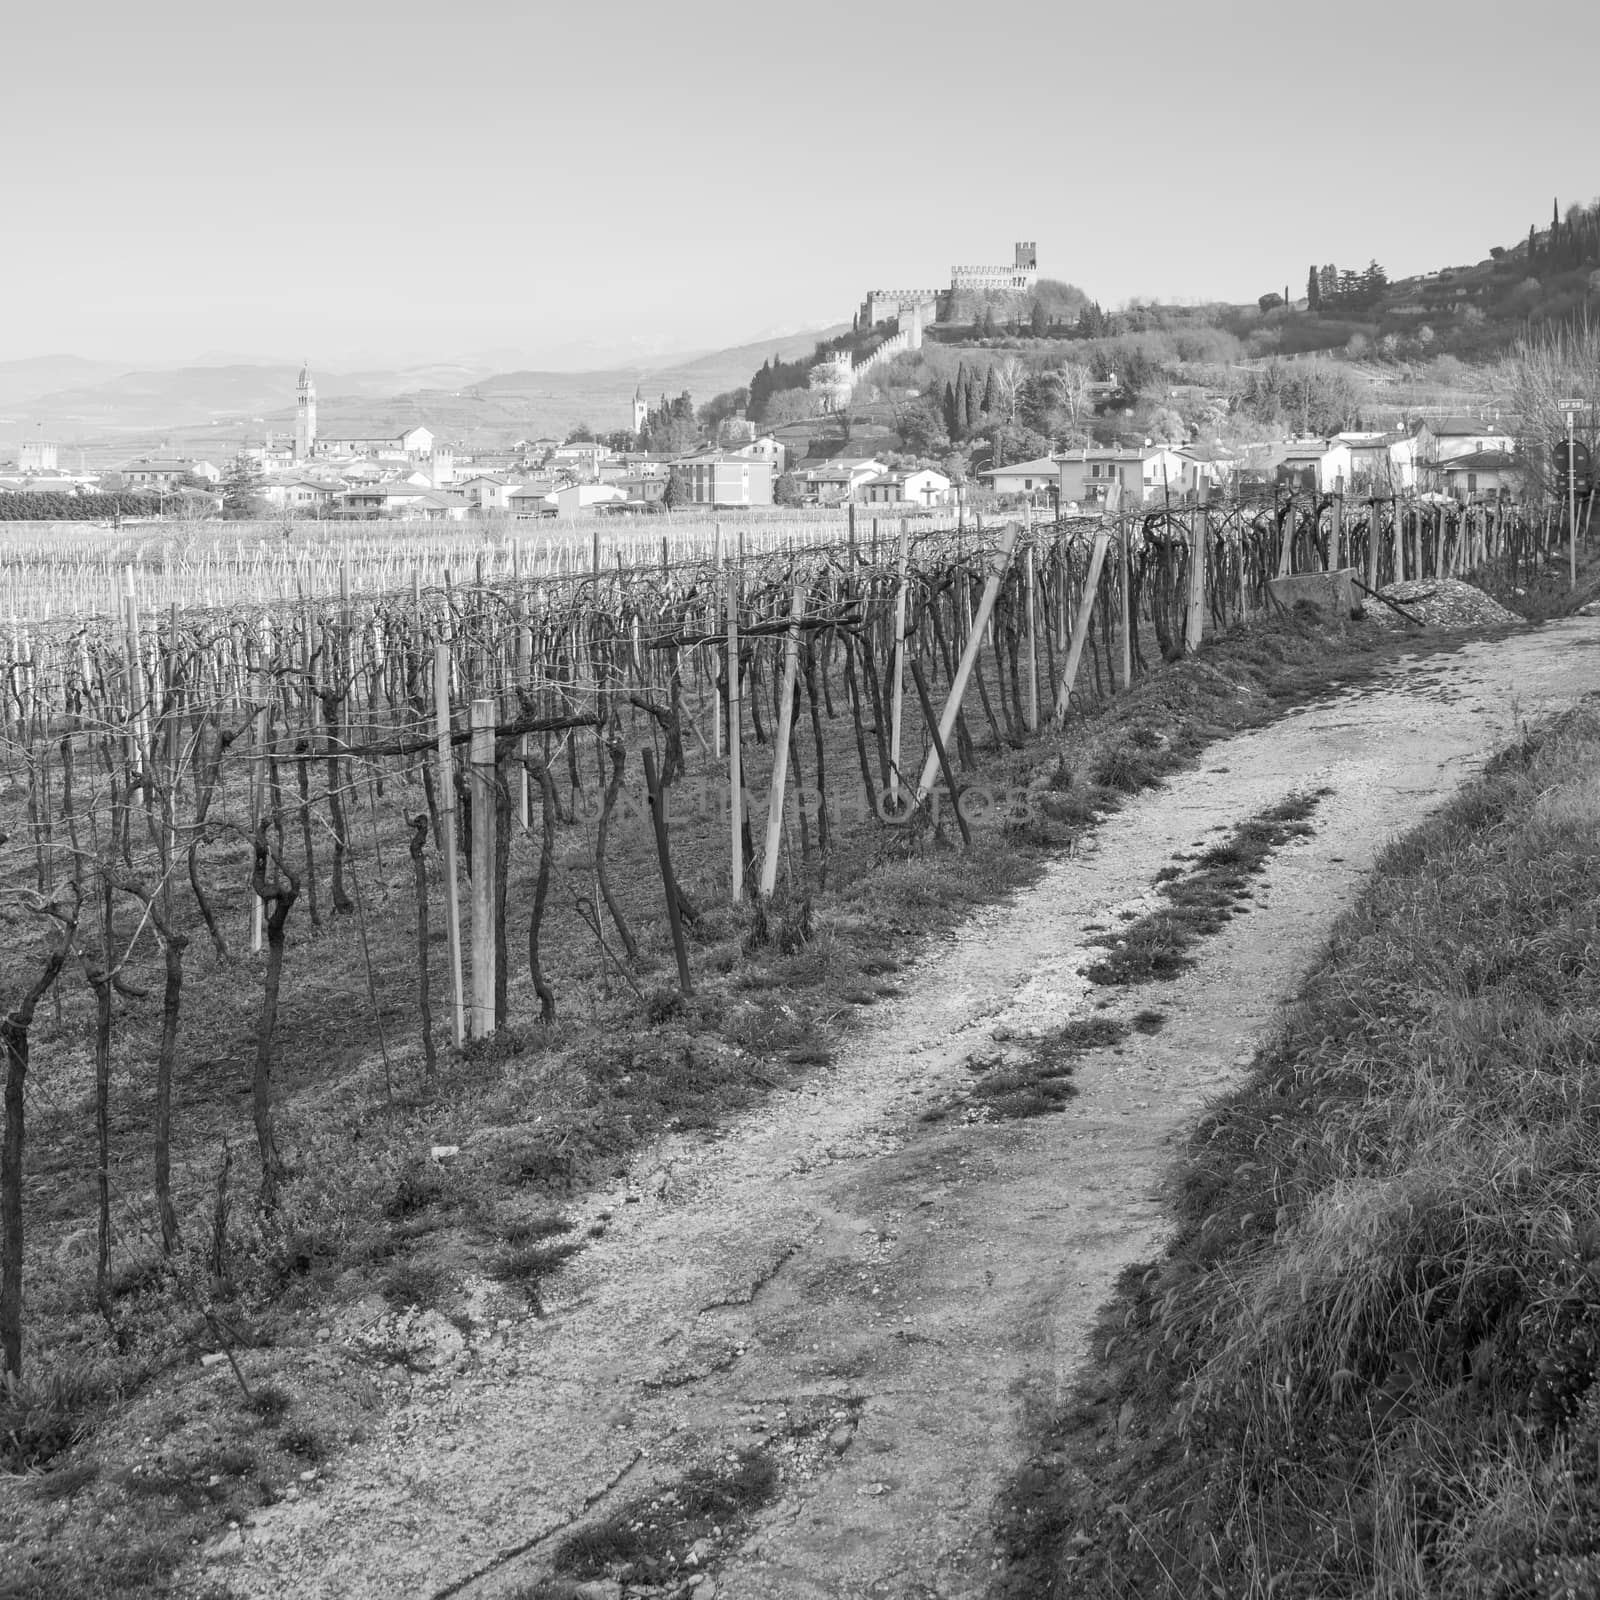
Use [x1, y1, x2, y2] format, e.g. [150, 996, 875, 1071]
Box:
[0, 492, 1580, 1594]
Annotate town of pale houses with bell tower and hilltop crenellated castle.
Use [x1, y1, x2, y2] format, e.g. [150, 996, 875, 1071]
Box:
[0, 236, 1542, 523]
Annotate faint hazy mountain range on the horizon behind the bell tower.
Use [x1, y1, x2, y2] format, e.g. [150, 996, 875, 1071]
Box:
[0, 328, 840, 454]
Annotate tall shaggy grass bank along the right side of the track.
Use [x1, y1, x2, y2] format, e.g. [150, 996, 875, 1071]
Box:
[995, 706, 1600, 1600]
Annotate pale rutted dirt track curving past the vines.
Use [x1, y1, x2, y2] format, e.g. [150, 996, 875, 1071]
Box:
[184, 618, 1600, 1600]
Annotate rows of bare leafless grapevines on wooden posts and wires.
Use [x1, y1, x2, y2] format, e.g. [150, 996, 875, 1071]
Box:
[0, 496, 1550, 1401]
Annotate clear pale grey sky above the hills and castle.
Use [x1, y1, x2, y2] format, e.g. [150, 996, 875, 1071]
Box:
[0, 0, 1600, 366]
